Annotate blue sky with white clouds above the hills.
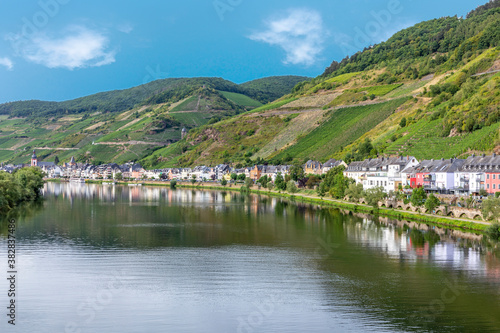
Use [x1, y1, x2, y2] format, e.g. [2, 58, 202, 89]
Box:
[0, 0, 486, 103]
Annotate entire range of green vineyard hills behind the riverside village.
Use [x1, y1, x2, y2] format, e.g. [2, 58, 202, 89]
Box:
[0, 0, 500, 168]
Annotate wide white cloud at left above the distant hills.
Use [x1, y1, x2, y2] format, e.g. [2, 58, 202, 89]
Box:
[20, 26, 116, 70]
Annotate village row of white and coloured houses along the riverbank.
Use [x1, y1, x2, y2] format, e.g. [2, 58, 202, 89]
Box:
[0, 151, 500, 196]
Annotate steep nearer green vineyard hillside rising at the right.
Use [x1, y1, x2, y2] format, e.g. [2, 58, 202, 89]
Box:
[142, 0, 500, 167]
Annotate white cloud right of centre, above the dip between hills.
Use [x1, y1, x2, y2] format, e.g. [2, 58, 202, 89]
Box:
[249, 9, 326, 66]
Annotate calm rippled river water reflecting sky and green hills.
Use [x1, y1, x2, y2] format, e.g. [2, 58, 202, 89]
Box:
[0, 183, 500, 333]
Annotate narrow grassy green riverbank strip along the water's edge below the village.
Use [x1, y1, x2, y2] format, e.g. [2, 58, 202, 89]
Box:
[48, 179, 491, 234]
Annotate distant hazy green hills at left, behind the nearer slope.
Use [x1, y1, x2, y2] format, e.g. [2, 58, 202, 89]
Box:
[0, 76, 307, 164]
